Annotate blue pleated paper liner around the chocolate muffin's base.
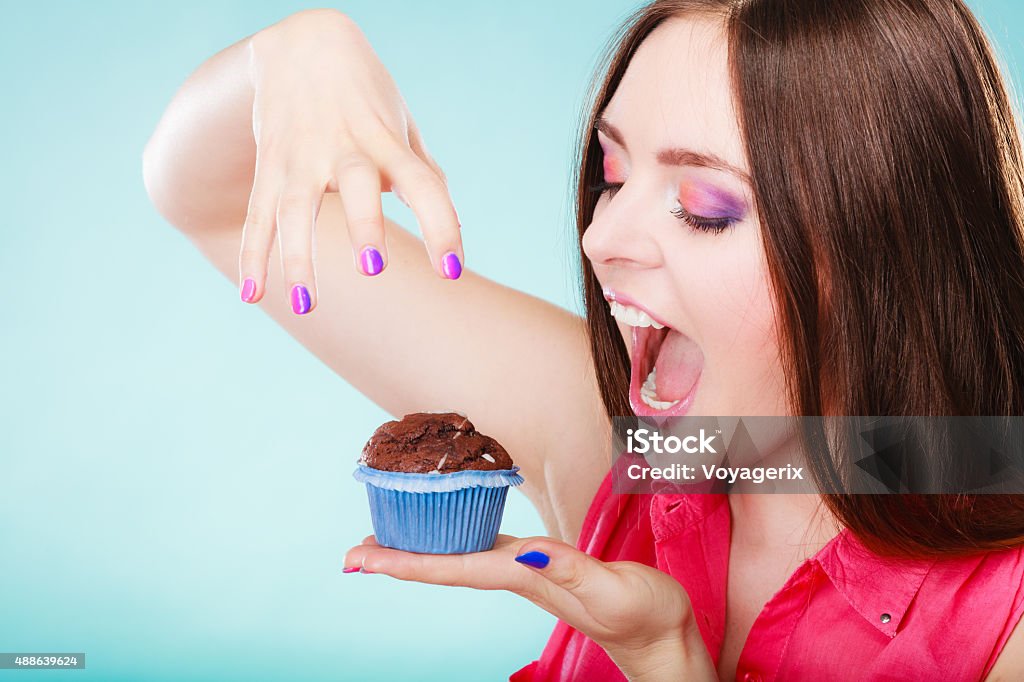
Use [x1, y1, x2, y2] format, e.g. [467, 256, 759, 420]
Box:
[353, 465, 523, 554]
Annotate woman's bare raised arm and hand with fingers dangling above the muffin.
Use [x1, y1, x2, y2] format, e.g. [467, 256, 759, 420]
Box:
[143, 10, 609, 542]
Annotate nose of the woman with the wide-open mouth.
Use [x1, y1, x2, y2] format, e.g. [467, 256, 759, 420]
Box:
[583, 183, 663, 269]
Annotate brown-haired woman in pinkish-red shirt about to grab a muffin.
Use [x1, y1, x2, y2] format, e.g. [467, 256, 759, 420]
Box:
[144, 0, 1024, 680]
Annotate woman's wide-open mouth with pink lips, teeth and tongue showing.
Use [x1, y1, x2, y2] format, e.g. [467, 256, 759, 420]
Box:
[606, 294, 703, 417]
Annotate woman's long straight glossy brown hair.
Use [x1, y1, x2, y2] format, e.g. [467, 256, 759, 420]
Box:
[575, 0, 1024, 557]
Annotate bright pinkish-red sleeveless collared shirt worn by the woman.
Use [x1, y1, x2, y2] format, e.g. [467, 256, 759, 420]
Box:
[510, 466, 1024, 682]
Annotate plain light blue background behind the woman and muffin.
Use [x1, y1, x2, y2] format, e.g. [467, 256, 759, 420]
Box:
[0, 0, 1024, 680]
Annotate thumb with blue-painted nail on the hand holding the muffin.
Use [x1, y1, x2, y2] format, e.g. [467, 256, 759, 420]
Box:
[515, 540, 616, 599]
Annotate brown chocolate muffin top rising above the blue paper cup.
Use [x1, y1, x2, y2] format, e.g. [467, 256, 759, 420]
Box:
[359, 412, 512, 474]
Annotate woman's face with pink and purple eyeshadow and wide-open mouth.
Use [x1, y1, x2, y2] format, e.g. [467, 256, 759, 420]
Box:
[583, 18, 790, 416]
